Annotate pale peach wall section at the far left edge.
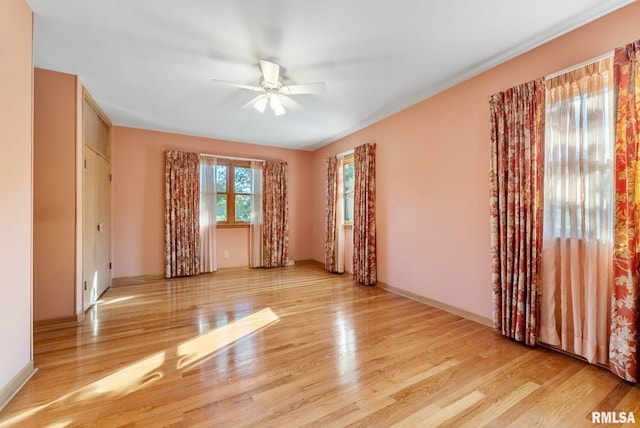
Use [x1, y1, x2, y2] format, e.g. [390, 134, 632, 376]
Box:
[0, 0, 33, 392]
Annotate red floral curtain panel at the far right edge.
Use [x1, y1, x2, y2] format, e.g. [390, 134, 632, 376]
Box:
[609, 40, 640, 382]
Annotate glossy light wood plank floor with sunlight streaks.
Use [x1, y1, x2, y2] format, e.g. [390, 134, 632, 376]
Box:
[0, 264, 640, 427]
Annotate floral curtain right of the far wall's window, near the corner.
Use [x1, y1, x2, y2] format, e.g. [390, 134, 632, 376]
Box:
[262, 161, 289, 267]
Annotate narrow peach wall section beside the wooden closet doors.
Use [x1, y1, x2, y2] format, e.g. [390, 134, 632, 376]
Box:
[33, 68, 76, 321]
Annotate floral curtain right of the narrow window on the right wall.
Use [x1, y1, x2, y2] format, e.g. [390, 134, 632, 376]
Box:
[353, 143, 377, 285]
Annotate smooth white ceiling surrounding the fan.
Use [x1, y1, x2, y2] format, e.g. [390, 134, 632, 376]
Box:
[27, 0, 632, 150]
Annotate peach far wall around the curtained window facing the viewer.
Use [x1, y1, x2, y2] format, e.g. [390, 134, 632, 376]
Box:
[112, 127, 311, 278]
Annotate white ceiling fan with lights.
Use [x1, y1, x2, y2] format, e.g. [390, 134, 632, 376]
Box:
[212, 60, 327, 116]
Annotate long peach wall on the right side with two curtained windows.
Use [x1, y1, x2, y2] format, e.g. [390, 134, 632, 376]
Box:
[311, 3, 640, 318]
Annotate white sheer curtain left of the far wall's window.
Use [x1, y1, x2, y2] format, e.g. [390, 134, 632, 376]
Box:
[200, 155, 218, 272]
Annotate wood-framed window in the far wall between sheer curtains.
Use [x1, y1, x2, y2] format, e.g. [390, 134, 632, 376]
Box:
[216, 159, 253, 226]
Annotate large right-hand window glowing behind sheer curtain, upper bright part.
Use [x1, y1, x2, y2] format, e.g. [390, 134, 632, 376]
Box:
[544, 59, 614, 242]
